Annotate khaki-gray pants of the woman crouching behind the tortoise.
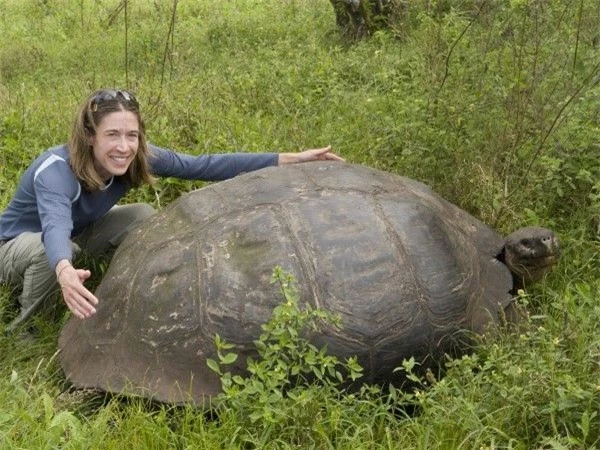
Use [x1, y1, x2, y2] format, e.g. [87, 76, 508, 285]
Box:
[0, 203, 155, 331]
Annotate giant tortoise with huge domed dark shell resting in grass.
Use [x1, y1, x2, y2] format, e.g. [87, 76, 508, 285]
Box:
[59, 162, 558, 403]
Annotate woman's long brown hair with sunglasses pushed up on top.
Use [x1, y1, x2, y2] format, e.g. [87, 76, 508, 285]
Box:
[68, 89, 154, 191]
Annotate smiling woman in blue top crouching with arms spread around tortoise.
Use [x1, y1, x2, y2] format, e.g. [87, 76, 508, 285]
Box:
[0, 89, 342, 330]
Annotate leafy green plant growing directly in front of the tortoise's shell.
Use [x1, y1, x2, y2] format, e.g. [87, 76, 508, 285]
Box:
[207, 267, 362, 426]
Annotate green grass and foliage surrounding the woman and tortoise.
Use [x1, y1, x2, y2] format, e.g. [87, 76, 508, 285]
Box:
[0, 0, 600, 449]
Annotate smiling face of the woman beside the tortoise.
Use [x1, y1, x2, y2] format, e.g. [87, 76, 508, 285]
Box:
[90, 111, 140, 180]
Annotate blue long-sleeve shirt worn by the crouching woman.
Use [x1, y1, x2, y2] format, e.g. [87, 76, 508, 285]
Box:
[0, 145, 278, 268]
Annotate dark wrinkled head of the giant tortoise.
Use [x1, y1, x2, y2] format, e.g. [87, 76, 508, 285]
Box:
[504, 227, 560, 289]
